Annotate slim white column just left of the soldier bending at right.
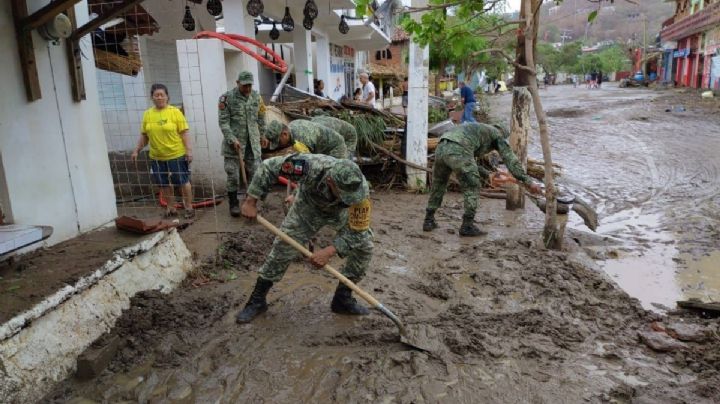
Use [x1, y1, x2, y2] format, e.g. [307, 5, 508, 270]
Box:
[405, 0, 430, 189]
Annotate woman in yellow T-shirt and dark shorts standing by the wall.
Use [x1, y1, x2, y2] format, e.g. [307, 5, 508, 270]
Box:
[130, 84, 195, 219]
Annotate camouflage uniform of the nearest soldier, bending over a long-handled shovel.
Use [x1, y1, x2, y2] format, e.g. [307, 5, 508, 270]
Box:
[248, 154, 373, 282]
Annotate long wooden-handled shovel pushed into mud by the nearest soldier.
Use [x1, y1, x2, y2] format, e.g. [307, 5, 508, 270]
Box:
[257, 215, 432, 352]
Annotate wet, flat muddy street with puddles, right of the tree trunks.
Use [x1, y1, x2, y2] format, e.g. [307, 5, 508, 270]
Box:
[490, 83, 720, 310]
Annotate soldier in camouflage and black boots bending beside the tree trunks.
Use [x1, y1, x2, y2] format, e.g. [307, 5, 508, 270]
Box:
[423, 123, 540, 236]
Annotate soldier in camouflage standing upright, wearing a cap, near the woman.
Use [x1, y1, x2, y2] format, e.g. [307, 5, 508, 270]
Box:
[218, 71, 267, 217]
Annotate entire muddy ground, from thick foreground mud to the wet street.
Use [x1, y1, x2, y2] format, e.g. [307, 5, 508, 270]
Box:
[44, 88, 720, 403]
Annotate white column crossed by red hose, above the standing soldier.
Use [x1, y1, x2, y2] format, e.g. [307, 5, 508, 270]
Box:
[223, 1, 260, 91]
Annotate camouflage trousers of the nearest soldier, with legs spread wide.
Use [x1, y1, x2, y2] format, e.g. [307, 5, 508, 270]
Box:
[258, 193, 373, 282]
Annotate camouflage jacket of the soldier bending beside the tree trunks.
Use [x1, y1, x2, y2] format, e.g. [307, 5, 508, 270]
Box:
[440, 123, 531, 184]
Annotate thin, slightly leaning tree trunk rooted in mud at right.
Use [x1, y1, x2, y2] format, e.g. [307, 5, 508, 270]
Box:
[522, 0, 563, 250]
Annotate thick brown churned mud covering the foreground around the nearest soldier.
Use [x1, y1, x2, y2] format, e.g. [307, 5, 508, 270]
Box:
[45, 188, 720, 403]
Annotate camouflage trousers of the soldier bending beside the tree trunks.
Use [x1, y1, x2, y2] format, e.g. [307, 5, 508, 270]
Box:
[427, 140, 480, 218]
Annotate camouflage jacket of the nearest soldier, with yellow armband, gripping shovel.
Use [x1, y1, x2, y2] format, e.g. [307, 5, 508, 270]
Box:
[247, 153, 373, 257]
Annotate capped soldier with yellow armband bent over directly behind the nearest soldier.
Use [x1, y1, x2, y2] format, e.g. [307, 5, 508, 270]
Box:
[265, 119, 347, 159]
